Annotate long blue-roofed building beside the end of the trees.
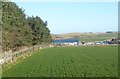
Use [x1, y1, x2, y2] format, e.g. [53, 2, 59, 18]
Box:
[52, 38, 79, 45]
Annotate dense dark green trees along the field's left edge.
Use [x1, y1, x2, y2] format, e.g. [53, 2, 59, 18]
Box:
[2, 2, 51, 51]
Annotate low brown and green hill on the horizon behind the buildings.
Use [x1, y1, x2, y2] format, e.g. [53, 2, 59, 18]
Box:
[52, 32, 118, 42]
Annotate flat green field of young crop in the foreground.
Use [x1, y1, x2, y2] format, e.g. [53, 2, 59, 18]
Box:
[3, 46, 118, 77]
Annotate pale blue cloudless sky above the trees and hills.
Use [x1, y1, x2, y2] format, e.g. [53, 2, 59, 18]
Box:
[16, 2, 118, 34]
